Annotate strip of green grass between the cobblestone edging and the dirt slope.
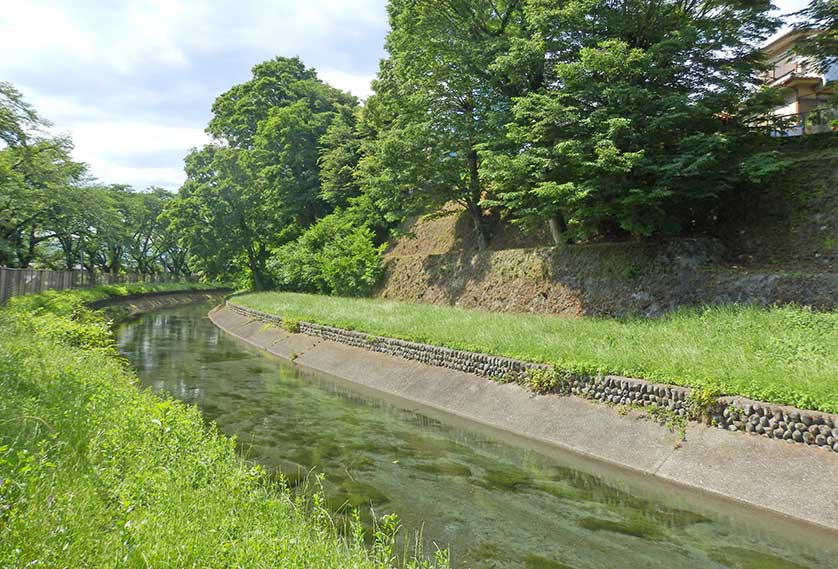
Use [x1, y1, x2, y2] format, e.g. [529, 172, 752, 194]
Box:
[234, 292, 838, 413]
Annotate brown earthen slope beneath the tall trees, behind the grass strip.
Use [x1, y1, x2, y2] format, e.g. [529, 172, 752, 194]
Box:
[378, 135, 838, 316]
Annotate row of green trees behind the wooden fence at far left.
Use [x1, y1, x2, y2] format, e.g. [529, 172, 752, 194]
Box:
[0, 83, 189, 275]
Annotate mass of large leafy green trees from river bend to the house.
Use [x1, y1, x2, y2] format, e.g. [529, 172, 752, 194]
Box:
[3, 0, 838, 294]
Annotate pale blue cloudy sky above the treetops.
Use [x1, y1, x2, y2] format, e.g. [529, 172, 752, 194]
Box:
[0, 0, 806, 191]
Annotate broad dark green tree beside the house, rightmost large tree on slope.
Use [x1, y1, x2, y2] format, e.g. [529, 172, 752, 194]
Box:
[492, 0, 777, 241]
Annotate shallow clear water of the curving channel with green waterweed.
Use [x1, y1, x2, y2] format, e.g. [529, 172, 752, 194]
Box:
[118, 303, 838, 569]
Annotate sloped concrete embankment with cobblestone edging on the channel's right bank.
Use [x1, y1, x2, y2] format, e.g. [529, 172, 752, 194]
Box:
[210, 303, 838, 530]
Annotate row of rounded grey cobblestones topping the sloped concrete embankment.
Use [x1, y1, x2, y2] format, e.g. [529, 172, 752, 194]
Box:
[227, 301, 838, 452]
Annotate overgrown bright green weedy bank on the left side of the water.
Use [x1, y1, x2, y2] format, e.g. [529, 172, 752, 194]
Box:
[0, 285, 446, 568]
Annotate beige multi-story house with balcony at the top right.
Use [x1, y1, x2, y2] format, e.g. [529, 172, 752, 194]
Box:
[762, 32, 838, 136]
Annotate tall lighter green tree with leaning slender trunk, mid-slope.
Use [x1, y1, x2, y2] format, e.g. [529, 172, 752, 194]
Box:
[359, 0, 521, 248]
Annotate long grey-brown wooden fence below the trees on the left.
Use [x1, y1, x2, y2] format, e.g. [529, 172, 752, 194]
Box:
[0, 267, 189, 302]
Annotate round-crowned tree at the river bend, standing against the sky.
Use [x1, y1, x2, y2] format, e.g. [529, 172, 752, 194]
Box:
[171, 57, 357, 289]
